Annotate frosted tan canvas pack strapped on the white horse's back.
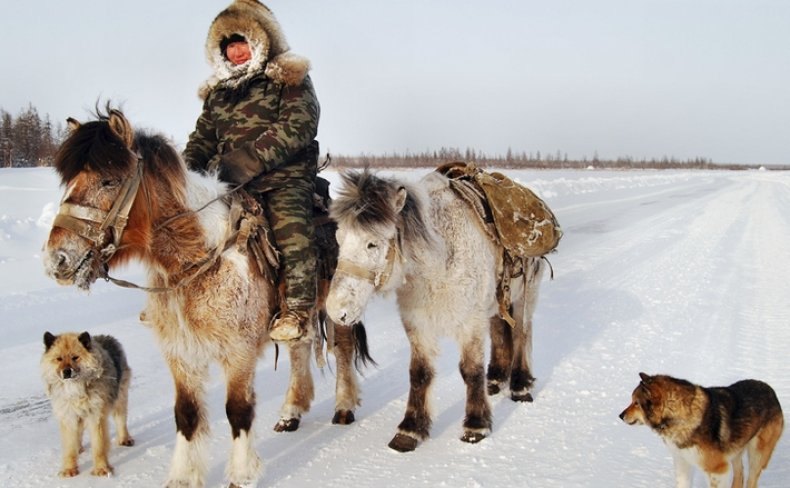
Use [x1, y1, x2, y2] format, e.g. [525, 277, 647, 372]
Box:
[436, 161, 562, 327]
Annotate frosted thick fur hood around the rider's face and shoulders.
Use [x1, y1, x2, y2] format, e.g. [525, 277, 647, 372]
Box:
[198, 0, 310, 100]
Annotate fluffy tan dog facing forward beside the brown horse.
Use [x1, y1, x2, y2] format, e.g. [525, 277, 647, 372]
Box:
[41, 332, 134, 477]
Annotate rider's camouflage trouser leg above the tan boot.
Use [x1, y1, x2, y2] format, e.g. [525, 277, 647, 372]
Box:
[257, 180, 316, 311]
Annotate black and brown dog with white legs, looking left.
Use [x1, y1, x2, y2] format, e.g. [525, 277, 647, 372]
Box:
[620, 373, 784, 488]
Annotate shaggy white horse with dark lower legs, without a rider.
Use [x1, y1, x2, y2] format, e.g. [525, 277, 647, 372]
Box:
[327, 170, 543, 451]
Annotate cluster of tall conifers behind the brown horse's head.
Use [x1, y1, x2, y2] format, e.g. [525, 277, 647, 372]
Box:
[0, 104, 64, 168]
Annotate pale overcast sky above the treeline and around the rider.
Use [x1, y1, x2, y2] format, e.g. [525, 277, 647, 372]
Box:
[0, 0, 790, 164]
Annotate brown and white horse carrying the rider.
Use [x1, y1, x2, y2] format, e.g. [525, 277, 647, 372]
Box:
[44, 105, 366, 486]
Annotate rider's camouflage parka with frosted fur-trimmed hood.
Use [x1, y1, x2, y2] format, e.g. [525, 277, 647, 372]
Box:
[184, 0, 320, 192]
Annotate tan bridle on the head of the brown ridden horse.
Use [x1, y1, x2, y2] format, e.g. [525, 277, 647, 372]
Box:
[52, 153, 143, 277]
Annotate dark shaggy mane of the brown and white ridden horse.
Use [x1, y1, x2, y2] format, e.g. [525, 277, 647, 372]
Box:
[54, 104, 186, 189]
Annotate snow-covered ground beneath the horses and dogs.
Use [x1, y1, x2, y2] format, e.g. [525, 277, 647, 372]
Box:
[0, 169, 790, 488]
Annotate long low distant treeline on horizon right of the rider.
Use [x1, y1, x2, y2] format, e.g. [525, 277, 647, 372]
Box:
[331, 147, 790, 170]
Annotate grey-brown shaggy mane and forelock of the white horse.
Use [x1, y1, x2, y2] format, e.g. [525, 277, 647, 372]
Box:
[330, 169, 434, 252]
